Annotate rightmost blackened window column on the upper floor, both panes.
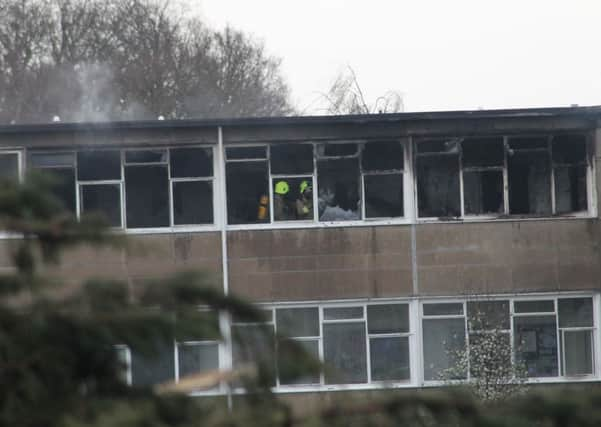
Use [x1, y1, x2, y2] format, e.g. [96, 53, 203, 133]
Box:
[551, 135, 588, 214]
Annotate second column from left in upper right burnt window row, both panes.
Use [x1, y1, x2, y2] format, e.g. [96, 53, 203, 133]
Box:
[461, 137, 505, 215]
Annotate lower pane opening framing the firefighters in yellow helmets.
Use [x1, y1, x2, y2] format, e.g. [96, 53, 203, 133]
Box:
[273, 177, 313, 221]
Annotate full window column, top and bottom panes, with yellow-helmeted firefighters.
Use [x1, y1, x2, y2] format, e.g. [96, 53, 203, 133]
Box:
[270, 144, 314, 221]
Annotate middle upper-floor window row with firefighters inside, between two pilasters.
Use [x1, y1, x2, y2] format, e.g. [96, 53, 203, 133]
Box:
[225, 140, 405, 224]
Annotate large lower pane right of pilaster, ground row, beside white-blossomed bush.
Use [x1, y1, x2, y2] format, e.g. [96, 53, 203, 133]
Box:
[423, 319, 467, 381]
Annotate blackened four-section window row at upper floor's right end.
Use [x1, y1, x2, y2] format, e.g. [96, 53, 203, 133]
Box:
[415, 134, 591, 218]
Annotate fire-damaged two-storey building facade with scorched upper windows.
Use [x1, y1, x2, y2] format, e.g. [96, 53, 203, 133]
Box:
[0, 107, 601, 394]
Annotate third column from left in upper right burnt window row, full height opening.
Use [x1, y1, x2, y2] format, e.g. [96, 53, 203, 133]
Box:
[507, 137, 552, 215]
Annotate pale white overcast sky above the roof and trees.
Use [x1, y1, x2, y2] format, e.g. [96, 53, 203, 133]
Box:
[192, 0, 601, 114]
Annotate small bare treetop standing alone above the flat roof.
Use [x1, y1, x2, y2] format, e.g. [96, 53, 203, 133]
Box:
[320, 66, 403, 114]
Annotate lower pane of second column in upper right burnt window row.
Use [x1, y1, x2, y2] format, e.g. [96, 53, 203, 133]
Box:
[463, 170, 503, 215]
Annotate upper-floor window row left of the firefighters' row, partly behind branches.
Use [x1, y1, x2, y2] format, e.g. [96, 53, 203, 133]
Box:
[29, 147, 214, 229]
